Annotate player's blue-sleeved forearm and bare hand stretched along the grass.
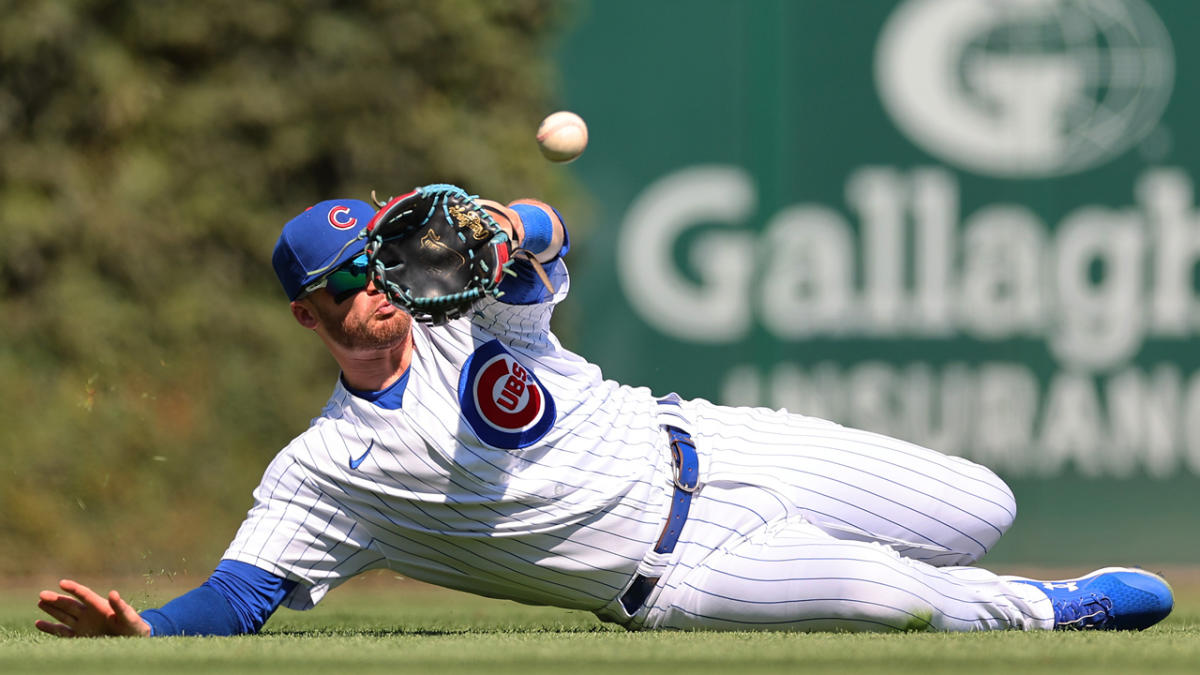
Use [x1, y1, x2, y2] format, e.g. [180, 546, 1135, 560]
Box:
[36, 560, 296, 638]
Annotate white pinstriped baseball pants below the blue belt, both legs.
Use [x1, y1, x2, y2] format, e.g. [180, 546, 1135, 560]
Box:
[630, 401, 1054, 631]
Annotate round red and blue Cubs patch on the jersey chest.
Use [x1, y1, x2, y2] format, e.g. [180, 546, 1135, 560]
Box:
[458, 340, 556, 450]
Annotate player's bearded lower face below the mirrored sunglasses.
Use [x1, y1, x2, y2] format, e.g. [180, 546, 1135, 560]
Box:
[310, 277, 412, 351]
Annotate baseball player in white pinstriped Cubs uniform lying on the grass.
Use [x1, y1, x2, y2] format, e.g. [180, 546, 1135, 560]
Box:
[37, 192, 1174, 637]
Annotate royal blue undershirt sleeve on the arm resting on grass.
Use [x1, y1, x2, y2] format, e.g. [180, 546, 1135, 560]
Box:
[142, 560, 296, 637]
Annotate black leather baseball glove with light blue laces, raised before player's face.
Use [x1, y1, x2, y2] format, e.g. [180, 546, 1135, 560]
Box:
[366, 184, 511, 325]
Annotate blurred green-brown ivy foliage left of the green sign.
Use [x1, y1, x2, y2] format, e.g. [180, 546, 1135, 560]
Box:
[0, 0, 572, 574]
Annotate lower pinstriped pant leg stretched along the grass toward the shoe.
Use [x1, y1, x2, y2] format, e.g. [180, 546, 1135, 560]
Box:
[641, 509, 1054, 631]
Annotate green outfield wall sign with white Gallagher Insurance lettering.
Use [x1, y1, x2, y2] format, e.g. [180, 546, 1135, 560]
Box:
[560, 0, 1200, 562]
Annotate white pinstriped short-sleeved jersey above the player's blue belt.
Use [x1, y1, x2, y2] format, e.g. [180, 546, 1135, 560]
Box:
[223, 264, 668, 609]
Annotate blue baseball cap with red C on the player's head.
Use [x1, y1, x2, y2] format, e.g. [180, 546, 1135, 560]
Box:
[271, 199, 376, 300]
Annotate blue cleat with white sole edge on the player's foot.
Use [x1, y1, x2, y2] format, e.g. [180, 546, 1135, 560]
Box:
[1006, 567, 1175, 631]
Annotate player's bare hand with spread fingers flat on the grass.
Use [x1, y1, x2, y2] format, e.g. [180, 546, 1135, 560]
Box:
[34, 579, 150, 638]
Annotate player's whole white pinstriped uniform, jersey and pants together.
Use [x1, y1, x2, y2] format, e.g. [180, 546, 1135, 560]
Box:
[224, 262, 1052, 631]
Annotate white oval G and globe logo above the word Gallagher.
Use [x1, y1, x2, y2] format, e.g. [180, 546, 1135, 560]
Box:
[875, 0, 1175, 178]
